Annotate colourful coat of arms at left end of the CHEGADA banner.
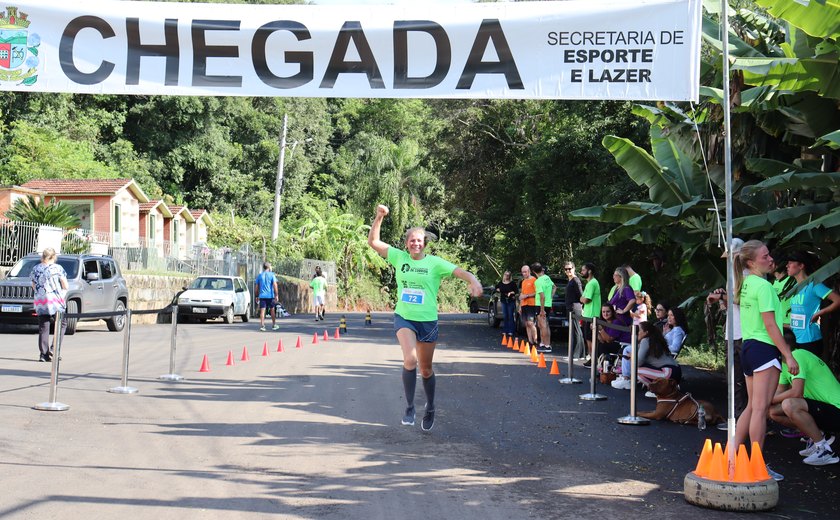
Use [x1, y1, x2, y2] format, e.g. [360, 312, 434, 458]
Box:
[0, 6, 41, 85]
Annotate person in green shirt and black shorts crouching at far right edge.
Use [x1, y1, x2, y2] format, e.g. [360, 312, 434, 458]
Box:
[768, 349, 840, 466]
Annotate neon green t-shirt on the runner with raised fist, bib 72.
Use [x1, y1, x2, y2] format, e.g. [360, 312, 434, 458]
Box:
[388, 247, 455, 321]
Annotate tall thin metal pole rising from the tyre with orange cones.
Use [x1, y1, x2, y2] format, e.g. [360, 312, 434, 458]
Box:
[720, 0, 738, 478]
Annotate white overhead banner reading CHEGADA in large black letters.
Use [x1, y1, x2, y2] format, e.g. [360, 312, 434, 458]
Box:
[0, 0, 701, 101]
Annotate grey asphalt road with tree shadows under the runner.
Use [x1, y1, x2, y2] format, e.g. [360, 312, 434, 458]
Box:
[0, 314, 840, 520]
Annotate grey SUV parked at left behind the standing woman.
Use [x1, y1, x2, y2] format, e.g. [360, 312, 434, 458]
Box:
[0, 253, 128, 335]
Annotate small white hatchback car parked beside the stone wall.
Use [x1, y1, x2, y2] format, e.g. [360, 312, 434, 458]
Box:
[178, 276, 251, 323]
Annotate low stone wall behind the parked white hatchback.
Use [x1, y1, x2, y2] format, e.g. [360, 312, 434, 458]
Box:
[123, 273, 338, 323]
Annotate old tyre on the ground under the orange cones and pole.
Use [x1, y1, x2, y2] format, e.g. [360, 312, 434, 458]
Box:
[683, 471, 779, 511]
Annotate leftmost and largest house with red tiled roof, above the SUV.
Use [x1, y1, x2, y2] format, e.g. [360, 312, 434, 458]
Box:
[23, 179, 149, 247]
